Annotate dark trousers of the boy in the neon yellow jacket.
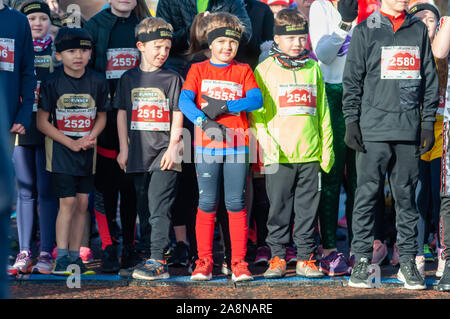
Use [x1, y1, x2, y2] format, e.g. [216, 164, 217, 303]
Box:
[266, 162, 320, 260]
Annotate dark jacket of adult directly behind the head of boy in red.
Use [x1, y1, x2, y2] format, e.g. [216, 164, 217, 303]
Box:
[156, 0, 252, 56]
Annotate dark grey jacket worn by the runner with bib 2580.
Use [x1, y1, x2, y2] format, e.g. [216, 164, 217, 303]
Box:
[342, 11, 439, 142]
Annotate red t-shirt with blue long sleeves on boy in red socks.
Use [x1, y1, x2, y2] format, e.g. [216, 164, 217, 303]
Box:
[179, 60, 262, 155]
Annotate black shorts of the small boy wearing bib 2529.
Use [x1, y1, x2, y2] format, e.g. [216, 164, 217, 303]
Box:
[51, 173, 94, 198]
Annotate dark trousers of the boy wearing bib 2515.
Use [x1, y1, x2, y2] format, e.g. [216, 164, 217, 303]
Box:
[133, 171, 178, 260]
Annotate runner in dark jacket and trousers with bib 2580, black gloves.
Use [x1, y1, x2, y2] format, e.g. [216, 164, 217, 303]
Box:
[343, 0, 439, 289]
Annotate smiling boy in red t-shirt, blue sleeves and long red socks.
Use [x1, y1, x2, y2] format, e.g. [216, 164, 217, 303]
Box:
[179, 13, 262, 281]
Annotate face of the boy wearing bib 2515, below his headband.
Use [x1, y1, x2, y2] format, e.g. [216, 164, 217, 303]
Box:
[137, 39, 172, 68]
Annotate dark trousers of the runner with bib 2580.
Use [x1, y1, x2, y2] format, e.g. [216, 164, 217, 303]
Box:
[352, 141, 419, 263]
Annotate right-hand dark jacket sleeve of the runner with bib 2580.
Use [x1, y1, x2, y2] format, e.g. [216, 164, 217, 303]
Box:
[422, 24, 439, 130]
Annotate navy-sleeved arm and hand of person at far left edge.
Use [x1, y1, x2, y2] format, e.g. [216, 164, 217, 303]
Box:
[11, 17, 37, 134]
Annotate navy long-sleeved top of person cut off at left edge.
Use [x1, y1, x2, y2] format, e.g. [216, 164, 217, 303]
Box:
[0, 6, 37, 129]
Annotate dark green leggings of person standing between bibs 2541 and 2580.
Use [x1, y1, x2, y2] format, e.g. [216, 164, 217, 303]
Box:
[319, 83, 356, 249]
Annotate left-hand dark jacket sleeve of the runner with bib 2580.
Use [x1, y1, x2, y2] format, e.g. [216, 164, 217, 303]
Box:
[342, 27, 367, 124]
